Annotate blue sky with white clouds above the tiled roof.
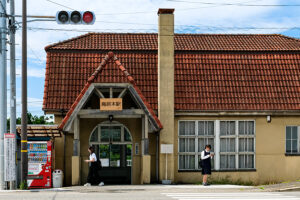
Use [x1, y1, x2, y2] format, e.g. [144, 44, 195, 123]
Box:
[7, 0, 300, 117]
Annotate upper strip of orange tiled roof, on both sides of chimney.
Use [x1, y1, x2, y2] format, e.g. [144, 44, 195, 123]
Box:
[45, 33, 300, 51]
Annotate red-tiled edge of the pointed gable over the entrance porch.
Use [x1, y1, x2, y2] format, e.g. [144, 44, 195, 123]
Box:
[58, 51, 163, 130]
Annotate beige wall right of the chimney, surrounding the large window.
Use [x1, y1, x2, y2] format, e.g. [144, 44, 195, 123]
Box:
[174, 116, 300, 184]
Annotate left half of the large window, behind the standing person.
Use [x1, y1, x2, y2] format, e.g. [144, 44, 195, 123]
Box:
[178, 121, 215, 169]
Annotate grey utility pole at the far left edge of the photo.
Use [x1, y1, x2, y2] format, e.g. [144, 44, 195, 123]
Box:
[0, 0, 7, 190]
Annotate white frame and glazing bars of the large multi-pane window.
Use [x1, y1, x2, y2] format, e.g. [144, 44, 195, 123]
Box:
[177, 119, 255, 171]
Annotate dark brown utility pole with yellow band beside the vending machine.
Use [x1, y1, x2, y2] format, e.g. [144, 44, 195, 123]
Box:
[20, 0, 28, 185]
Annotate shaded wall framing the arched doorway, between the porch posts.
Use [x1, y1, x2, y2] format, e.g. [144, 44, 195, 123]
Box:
[80, 119, 142, 184]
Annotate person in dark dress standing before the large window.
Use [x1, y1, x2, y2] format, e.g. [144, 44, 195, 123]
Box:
[201, 144, 214, 186]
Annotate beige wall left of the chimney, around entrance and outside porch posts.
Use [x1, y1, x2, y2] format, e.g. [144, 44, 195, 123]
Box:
[54, 116, 156, 186]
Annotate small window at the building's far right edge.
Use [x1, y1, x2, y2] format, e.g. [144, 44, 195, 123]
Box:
[286, 126, 300, 154]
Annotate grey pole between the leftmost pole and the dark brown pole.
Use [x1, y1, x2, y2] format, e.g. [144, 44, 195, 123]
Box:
[9, 0, 18, 190]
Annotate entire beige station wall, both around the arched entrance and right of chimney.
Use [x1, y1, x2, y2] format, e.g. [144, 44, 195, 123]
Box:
[54, 113, 300, 185]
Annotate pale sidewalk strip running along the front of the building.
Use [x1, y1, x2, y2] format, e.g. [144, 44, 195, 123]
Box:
[0, 181, 300, 193]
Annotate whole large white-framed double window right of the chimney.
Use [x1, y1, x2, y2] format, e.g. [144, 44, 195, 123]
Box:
[178, 120, 255, 170]
